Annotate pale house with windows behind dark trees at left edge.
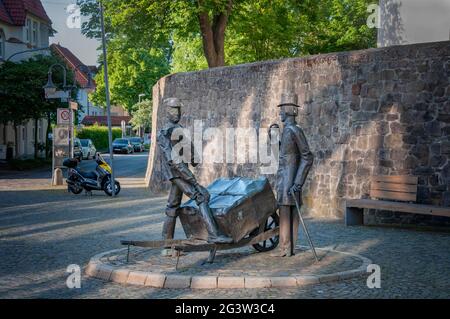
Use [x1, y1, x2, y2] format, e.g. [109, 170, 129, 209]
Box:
[0, 0, 53, 160]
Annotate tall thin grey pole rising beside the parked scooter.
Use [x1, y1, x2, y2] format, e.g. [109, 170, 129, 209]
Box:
[99, 1, 116, 197]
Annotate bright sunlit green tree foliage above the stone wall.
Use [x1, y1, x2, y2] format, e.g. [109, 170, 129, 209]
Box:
[78, 0, 377, 104]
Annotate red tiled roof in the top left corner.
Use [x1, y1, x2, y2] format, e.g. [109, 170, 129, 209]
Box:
[0, 0, 52, 26]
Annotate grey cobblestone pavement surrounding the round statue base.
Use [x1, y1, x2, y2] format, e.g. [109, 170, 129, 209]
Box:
[0, 185, 450, 298]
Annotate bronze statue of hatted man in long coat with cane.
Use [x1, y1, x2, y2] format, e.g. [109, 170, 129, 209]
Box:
[271, 94, 317, 259]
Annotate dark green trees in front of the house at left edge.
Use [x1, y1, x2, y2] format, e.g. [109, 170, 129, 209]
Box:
[0, 56, 76, 156]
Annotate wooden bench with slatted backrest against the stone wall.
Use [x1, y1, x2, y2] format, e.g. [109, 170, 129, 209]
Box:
[345, 176, 450, 226]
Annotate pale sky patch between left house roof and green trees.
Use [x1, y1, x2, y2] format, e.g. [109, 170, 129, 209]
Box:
[41, 0, 100, 65]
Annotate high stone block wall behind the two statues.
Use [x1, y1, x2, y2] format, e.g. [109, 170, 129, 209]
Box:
[147, 42, 450, 221]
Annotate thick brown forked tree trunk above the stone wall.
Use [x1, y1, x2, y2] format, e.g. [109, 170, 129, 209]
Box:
[198, 0, 233, 68]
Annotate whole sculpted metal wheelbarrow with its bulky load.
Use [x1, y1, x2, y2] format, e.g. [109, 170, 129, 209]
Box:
[121, 177, 279, 263]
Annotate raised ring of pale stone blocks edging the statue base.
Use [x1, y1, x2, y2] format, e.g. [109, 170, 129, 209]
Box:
[85, 246, 372, 289]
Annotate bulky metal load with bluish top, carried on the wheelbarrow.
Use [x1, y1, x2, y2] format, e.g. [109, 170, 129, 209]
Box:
[179, 177, 277, 243]
